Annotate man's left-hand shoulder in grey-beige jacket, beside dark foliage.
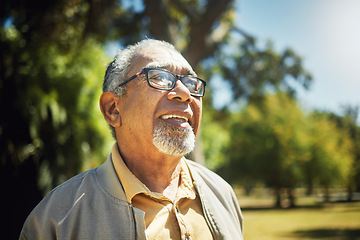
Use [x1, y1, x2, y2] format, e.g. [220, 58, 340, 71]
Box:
[20, 161, 141, 239]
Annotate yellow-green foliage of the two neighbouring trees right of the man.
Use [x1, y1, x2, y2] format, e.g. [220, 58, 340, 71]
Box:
[222, 94, 353, 196]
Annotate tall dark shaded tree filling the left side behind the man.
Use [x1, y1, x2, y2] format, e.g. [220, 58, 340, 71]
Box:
[0, 1, 116, 239]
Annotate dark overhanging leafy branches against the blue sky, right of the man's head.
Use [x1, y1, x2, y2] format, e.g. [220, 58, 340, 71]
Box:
[213, 36, 312, 101]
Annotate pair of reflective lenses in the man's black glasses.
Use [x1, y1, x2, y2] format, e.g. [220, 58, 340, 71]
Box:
[147, 69, 205, 96]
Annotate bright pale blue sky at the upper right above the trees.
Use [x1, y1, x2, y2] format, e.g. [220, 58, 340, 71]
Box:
[236, 0, 360, 122]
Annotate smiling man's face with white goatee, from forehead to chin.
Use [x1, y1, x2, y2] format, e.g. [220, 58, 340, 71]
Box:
[119, 47, 202, 156]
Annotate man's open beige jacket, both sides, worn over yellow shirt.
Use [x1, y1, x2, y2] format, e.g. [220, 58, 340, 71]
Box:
[20, 154, 243, 240]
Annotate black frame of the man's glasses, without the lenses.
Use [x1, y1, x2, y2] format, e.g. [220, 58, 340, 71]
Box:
[117, 68, 206, 97]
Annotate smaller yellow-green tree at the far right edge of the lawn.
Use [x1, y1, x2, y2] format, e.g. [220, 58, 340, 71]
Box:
[303, 111, 354, 200]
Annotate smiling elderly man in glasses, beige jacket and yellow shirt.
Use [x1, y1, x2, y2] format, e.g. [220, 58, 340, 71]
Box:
[20, 39, 243, 239]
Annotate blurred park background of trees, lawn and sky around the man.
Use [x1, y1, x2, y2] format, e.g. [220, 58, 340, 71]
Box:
[0, 0, 360, 239]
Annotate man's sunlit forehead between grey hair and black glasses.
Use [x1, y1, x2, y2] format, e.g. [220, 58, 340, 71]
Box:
[131, 47, 196, 75]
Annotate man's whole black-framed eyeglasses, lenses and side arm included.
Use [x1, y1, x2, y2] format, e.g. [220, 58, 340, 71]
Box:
[118, 68, 206, 97]
